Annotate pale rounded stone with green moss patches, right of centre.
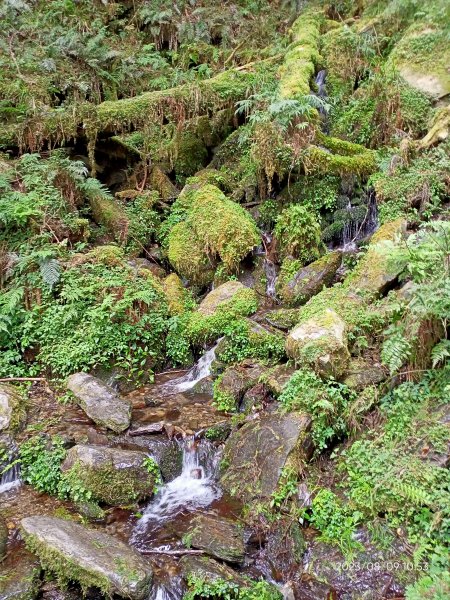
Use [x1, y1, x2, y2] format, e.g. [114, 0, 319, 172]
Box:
[286, 309, 350, 379]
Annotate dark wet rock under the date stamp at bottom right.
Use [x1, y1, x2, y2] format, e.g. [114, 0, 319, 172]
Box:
[305, 529, 415, 600]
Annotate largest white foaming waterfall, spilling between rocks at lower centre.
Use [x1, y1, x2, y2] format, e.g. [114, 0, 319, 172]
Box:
[131, 436, 222, 547]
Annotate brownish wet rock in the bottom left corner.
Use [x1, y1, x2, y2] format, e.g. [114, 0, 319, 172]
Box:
[0, 550, 41, 600]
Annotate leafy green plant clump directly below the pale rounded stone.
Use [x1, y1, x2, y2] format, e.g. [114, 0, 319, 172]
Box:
[279, 369, 355, 452]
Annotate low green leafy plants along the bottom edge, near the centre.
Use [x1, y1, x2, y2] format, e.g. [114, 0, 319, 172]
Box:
[183, 575, 281, 600]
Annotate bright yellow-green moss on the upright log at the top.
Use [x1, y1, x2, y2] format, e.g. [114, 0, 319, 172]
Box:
[279, 12, 321, 99]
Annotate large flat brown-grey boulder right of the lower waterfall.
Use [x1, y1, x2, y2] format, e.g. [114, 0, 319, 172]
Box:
[220, 412, 312, 502]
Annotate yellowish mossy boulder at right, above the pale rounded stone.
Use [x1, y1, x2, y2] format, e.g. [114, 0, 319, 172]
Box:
[352, 219, 406, 296]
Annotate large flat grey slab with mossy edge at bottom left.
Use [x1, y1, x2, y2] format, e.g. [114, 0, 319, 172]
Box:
[21, 516, 152, 600]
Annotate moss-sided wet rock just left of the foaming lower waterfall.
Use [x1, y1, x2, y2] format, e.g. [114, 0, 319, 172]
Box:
[61, 445, 155, 506]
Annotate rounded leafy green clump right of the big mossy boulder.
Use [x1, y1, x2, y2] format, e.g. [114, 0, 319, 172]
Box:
[274, 204, 322, 264]
